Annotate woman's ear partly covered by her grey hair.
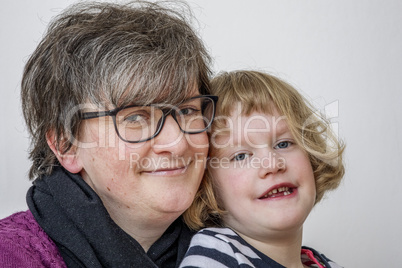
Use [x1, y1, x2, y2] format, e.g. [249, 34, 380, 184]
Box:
[46, 131, 82, 173]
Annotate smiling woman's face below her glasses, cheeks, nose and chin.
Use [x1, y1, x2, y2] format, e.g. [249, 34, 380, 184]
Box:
[68, 89, 209, 225]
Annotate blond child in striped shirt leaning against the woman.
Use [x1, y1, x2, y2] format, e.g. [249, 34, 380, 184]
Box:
[181, 71, 344, 268]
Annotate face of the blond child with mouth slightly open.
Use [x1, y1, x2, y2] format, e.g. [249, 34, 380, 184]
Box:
[210, 110, 316, 241]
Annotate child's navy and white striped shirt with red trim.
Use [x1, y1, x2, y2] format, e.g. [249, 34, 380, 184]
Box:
[180, 228, 342, 268]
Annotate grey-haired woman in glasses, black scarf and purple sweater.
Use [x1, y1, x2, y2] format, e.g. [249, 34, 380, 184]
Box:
[0, 2, 216, 267]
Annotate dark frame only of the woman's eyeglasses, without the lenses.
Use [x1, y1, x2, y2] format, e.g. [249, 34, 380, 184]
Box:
[80, 95, 219, 143]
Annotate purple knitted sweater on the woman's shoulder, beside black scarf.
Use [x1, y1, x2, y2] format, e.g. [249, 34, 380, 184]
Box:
[0, 210, 66, 268]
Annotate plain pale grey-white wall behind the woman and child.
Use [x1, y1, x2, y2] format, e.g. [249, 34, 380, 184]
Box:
[0, 0, 402, 267]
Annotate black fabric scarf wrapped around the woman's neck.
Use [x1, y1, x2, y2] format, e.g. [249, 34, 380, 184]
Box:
[27, 167, 193, 268]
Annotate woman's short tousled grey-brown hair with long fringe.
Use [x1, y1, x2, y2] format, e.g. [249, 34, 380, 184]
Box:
[21, 1, 211, 179]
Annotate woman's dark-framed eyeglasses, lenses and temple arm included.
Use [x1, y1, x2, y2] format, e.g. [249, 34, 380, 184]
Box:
[80, 96, 218, 143]
